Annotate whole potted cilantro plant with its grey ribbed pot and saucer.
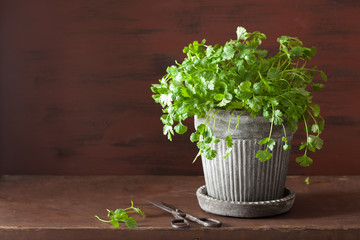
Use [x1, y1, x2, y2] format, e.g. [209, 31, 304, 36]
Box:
[151, 27, 327, 217]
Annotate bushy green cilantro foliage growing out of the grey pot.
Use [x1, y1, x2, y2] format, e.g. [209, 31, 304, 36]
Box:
[151, 27, 327, 166]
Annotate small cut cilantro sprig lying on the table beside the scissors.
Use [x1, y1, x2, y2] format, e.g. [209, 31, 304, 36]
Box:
[95, 201, 145, 228]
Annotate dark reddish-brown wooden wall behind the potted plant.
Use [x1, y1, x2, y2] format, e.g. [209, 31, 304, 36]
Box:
[0, 0, 360, 175]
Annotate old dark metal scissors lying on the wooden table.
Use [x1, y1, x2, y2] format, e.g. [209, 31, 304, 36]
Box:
[149, 201, 221, 228]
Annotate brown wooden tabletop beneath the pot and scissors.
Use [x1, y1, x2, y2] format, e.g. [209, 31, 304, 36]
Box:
[0, 175, 360, 240]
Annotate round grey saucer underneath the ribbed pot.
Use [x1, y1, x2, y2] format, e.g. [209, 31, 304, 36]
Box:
[196, 186, 295, 218]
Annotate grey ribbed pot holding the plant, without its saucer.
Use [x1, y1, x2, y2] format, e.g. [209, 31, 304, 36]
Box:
[195, 110, 293, 202]
